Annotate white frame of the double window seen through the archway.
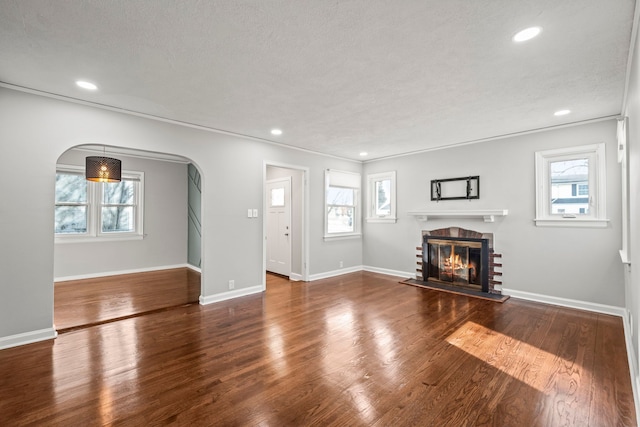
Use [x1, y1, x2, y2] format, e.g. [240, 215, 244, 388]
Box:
[55, 165, 144, 243]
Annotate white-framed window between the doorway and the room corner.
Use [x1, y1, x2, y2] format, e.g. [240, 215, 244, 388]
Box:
[324, 169, 360, 240]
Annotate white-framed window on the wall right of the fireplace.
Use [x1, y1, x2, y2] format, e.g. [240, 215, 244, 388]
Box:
[535, 144, 608, 227]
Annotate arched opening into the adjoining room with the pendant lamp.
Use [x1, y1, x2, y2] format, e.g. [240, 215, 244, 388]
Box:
[54, 145, 202, 332]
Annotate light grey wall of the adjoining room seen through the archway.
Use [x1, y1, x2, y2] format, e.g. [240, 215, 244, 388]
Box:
[53, 149, 188, 279]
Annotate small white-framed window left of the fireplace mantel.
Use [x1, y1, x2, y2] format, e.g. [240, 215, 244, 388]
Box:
[367, 171, 396, 222]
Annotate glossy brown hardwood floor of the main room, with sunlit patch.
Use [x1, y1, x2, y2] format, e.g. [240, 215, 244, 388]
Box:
[0, 272, 636, 426]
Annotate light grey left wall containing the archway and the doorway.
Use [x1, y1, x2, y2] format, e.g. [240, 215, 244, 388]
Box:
[0, 88, 362, 348]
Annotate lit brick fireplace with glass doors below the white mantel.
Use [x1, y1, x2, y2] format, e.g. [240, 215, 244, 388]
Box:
[416, 227, 502, 294]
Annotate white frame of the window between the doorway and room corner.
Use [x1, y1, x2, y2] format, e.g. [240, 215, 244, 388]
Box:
[323, 169, 362, 241]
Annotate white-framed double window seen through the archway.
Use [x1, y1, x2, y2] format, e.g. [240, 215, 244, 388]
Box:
[54, 166, 144, 242]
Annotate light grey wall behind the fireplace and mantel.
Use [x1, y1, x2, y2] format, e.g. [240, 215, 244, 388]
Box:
[364, 120, 624, 307]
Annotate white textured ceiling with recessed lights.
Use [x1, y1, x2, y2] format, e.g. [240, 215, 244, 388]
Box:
[0, 0, 635, 160]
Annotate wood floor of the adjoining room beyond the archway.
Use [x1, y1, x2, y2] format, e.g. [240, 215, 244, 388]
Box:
[54, 268, 200, 332]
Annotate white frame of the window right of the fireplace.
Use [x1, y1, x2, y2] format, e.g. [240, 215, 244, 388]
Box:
[534, 143, 609, 228]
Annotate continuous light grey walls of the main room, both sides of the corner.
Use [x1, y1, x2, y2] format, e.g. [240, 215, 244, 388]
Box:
[0, 83, 624, 348]
